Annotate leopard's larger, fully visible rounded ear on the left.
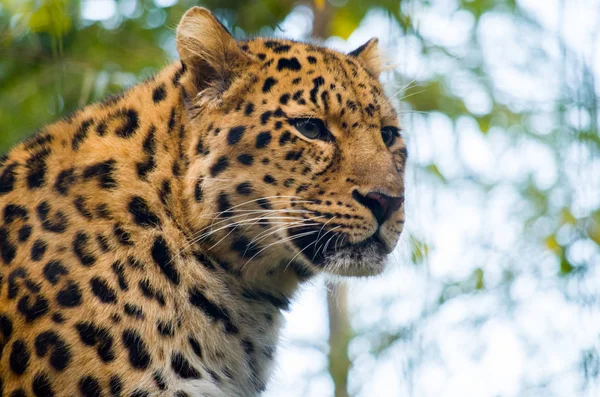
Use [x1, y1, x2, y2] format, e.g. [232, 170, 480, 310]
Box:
[177, 7, 251, 93]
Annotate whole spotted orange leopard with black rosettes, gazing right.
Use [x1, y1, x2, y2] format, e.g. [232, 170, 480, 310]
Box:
[0, 7, 407, 397]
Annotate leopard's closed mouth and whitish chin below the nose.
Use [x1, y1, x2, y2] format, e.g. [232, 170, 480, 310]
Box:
[290, 223, 391, 275]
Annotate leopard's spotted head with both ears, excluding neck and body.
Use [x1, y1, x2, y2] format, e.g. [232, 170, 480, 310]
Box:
[178, 10, 407, 276]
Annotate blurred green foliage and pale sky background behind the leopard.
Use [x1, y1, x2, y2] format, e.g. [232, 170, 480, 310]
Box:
[0, 0, 600, 397]
